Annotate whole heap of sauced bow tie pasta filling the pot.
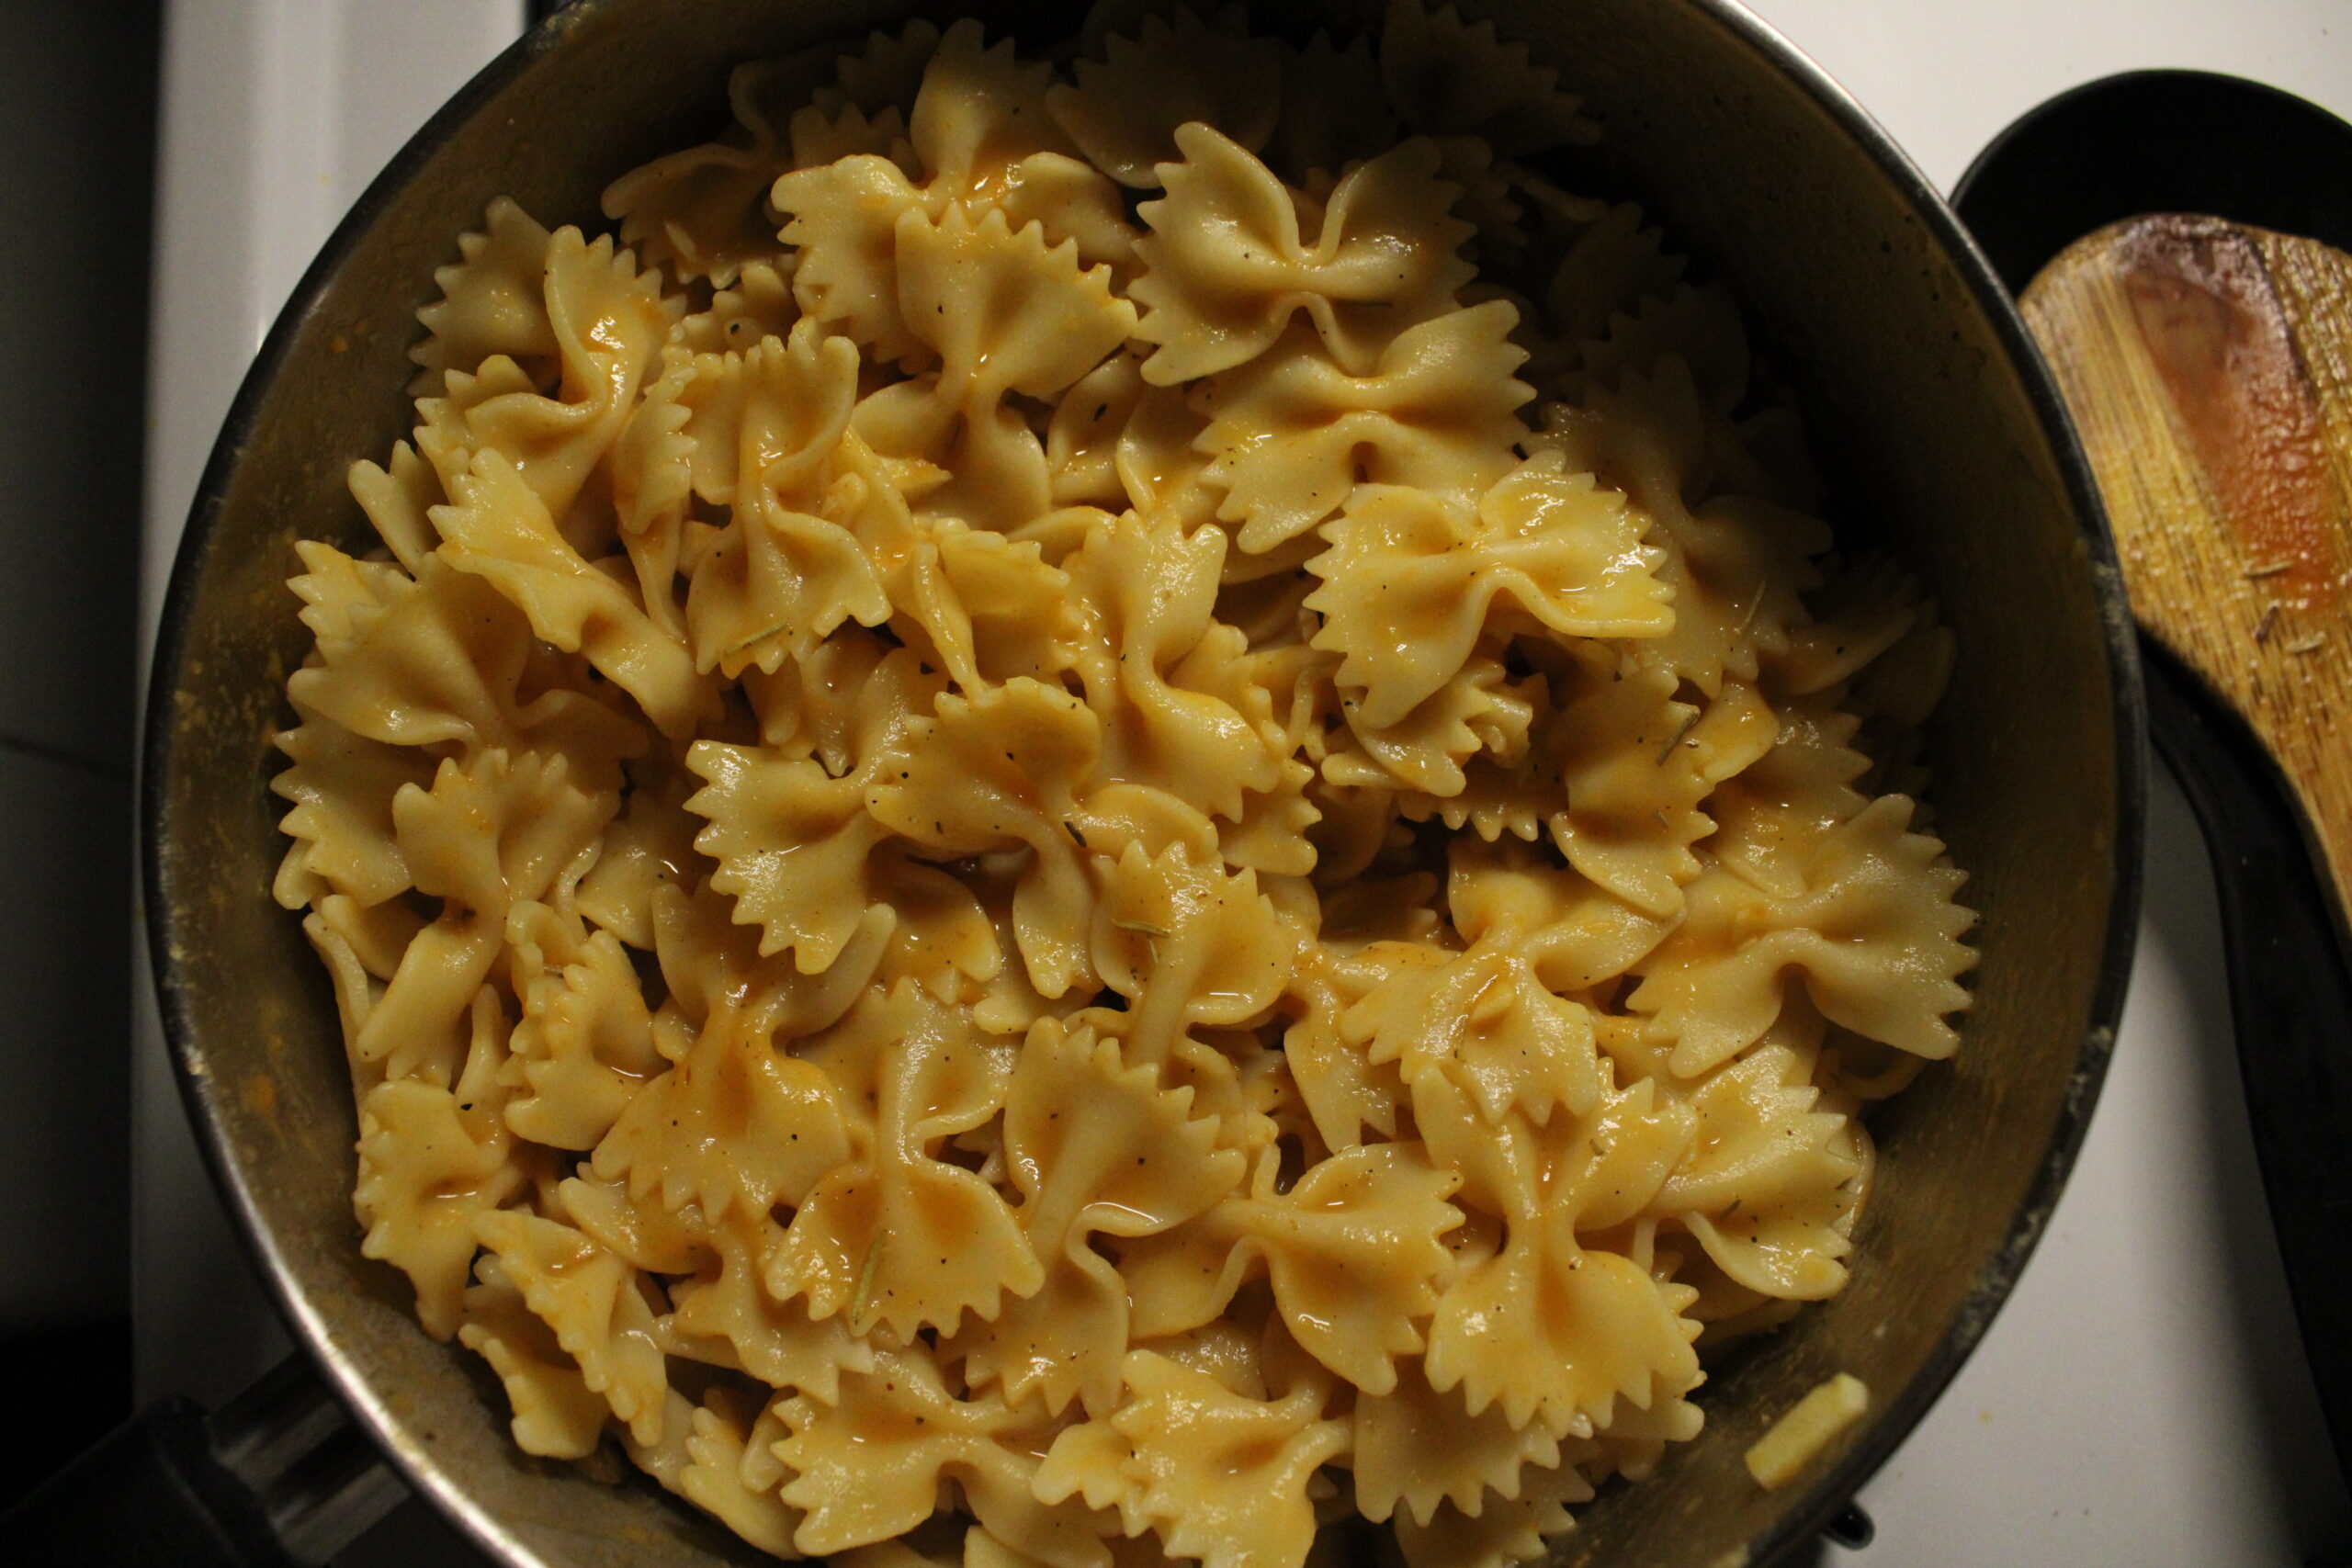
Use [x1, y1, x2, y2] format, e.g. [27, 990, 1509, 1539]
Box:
[276, 0, 1973, 1568]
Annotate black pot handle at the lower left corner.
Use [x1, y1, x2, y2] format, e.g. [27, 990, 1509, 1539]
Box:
[0, 1354, 407, 1568]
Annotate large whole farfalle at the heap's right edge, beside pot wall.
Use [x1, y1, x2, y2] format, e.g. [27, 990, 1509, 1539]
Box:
[1628, 795, 1975, 1077]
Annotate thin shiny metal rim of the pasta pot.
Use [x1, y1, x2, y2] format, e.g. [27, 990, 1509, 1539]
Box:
[139, 0, 2150, 1568]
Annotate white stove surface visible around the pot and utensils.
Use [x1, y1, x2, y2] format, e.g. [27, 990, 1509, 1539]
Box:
[134, 0, 2352, 1568]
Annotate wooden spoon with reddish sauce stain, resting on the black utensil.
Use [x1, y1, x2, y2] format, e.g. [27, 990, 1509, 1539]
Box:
[2020, 214, 2352, 921]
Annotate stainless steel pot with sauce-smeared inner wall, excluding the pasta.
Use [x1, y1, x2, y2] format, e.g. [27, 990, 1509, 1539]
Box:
[129, 0, 2145, 1568]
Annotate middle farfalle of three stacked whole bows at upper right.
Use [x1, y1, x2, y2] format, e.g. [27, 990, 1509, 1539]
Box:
[1194, 301, 1533, 555]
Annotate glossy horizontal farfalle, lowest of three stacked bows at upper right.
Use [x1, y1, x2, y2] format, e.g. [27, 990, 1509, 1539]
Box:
[1306, 454, 1675, 727]
